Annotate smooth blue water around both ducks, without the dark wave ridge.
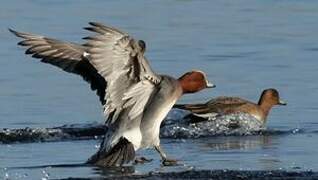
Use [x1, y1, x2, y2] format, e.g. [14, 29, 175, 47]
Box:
[0, 0, 318, 179]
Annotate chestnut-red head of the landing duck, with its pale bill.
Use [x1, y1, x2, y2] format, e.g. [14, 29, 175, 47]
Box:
[178, 70, 215, 93]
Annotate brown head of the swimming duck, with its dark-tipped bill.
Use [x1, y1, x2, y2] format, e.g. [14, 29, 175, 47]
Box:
[258, 89, 287, 107]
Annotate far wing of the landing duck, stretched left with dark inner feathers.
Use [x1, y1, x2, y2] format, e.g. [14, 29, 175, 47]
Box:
[9, 29, 106, 104]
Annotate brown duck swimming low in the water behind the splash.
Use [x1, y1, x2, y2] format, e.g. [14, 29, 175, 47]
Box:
[174, 89, 286, 124]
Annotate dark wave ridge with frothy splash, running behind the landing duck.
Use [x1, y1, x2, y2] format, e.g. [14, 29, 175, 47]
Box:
[0, 110, 306, 143]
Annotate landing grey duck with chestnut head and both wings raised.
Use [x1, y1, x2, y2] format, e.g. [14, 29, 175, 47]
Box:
[9, 22, 214, 166]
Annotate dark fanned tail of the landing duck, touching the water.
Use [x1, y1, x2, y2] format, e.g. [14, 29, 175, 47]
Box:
[87, 137, 135, 167]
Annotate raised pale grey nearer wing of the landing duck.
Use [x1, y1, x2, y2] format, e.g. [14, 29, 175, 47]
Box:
[85, 23, 161, 124]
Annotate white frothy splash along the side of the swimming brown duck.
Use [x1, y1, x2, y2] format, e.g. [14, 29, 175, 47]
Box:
[161, 111, 265, 138]
